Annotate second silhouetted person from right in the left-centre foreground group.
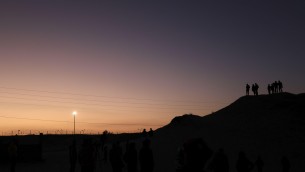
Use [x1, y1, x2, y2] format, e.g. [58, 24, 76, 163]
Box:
[124, 142, 138, 172]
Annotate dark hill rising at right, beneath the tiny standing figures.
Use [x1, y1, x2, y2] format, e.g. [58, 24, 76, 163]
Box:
[155, 93, 305, 171]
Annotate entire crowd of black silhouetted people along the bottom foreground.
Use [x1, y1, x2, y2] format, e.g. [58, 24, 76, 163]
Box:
[3, 134, 291, 172]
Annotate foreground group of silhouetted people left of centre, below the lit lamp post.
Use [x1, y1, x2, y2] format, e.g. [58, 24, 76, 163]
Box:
[69, 138, 154, 172]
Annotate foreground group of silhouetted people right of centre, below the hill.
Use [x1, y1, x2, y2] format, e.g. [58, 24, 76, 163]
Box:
[176, 138, 290, 172]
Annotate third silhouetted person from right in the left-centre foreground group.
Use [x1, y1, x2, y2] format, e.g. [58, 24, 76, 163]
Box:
[109, 143, 124, 172]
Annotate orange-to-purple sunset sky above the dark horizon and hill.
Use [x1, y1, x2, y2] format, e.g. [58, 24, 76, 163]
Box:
[0, 0, 305, 134]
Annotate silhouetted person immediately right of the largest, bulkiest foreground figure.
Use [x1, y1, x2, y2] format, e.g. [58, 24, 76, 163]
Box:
[209, 149, 229, 172]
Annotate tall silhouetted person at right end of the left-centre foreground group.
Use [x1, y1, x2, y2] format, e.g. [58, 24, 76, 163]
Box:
[139, 139, 155, 172]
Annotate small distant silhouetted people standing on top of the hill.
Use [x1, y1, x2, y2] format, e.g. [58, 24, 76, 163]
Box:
[246, 81, 283, 96]
